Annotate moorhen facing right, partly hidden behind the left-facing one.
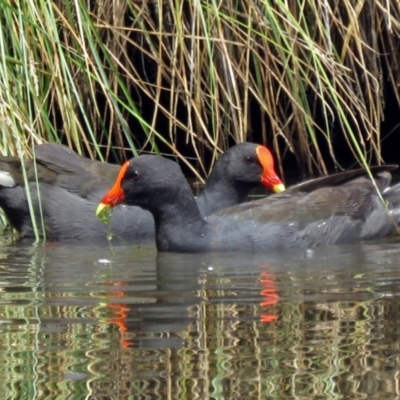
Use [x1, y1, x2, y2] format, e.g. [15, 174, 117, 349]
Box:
[0, 143, 284, 241]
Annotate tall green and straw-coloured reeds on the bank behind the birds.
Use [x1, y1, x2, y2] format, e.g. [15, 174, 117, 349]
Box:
[0, 0, 400, 183]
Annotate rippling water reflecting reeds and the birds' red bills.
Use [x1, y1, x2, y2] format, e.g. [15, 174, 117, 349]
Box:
[0, 238, 400, 400]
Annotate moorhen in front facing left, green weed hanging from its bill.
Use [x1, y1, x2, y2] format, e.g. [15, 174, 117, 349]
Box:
[97, 155, 400, 252]
